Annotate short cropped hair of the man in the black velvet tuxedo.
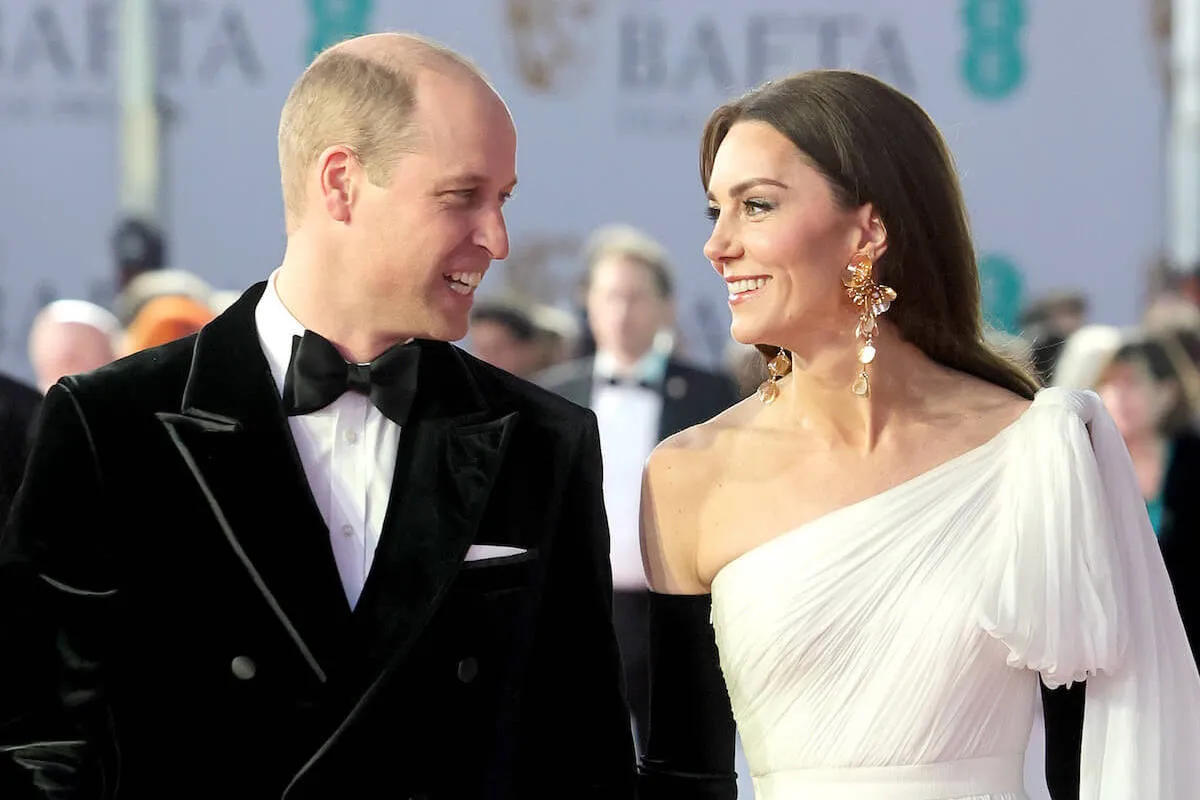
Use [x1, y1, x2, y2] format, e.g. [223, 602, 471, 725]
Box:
[278, 34, 491, 227]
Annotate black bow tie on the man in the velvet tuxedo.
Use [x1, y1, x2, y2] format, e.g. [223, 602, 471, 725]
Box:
[283, 331, 421, 425]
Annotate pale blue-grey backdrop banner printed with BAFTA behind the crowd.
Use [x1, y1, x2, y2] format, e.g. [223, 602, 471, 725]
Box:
[0, 0, 1164, 375]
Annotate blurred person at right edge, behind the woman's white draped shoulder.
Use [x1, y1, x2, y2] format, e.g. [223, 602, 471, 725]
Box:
[1096, 333, 1200, 656]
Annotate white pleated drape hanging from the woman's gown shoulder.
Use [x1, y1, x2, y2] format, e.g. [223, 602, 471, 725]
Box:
[980, 389, 1200, 800]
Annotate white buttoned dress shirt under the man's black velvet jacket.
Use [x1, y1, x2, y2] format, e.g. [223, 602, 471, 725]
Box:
[254, 273, 400, 608]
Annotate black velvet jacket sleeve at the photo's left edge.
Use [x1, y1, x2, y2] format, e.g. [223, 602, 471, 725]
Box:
[0, 379, 119, 800]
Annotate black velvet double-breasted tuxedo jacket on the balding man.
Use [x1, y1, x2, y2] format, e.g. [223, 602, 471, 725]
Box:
[0, 284, 634, 800]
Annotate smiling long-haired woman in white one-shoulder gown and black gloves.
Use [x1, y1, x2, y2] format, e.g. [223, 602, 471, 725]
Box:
[642, 71, 1200, 800]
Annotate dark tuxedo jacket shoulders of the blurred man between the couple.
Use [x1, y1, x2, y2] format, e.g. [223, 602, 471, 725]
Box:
[536, 357, 742, 440]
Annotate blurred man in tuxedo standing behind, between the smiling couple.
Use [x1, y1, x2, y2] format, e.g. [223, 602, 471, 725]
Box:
[540, 225, 739, 751]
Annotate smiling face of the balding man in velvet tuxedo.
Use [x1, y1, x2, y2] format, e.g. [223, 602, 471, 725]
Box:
[348, 72, 516, 341]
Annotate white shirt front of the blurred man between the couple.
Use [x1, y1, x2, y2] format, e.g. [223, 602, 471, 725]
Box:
[592, 351, 666, 590]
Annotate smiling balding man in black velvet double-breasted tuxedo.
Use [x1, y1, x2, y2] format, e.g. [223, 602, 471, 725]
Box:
[0, 34, 634, 800]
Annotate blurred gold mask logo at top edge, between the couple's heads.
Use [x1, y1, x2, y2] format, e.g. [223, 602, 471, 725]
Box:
[505, 0, 600, 92]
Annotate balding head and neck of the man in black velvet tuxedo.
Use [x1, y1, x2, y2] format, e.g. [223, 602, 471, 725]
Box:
[276, 34, 516, 361]
